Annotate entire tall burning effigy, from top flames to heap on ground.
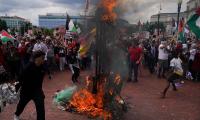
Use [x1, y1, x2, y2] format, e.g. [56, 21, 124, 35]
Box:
[55, 0, 127, 120]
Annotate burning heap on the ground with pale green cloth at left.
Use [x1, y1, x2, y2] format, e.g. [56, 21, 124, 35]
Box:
[54, 73, 126, 120]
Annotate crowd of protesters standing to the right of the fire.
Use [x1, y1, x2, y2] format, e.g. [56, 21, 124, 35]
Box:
[127, 36, 200, 98]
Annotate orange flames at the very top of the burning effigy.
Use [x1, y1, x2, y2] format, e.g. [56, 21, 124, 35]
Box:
[101, 0, 117, 22]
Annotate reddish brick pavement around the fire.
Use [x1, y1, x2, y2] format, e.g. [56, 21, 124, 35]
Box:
[0, 67, 200, 120]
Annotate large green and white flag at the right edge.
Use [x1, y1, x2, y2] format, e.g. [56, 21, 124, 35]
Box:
[187, 8, 200, 38]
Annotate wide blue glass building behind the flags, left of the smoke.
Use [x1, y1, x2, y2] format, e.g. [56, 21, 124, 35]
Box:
[39, 13, 92, 29]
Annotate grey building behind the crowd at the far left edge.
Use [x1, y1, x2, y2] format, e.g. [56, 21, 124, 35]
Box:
[0, 16, 30, 29]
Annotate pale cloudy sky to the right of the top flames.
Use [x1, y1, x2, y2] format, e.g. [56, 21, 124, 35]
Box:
[115, 0, 188, 23]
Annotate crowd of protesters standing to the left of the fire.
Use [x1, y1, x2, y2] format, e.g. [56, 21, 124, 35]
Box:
[0, 35, 92, 82]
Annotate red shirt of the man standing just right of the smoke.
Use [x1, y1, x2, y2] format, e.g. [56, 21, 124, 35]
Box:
[129, 47, 142, 62]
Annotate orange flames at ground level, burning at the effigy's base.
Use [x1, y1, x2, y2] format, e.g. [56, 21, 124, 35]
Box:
[69, 74, 123, 120]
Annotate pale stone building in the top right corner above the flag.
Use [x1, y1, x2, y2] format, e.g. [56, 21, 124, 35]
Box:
[187, 0, 200, 18]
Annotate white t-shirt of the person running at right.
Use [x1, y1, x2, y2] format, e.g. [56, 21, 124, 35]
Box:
[170, 58, 183, 73]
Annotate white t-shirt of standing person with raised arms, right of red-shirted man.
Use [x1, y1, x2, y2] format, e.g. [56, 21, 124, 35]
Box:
[158, 44, 169, 60]
